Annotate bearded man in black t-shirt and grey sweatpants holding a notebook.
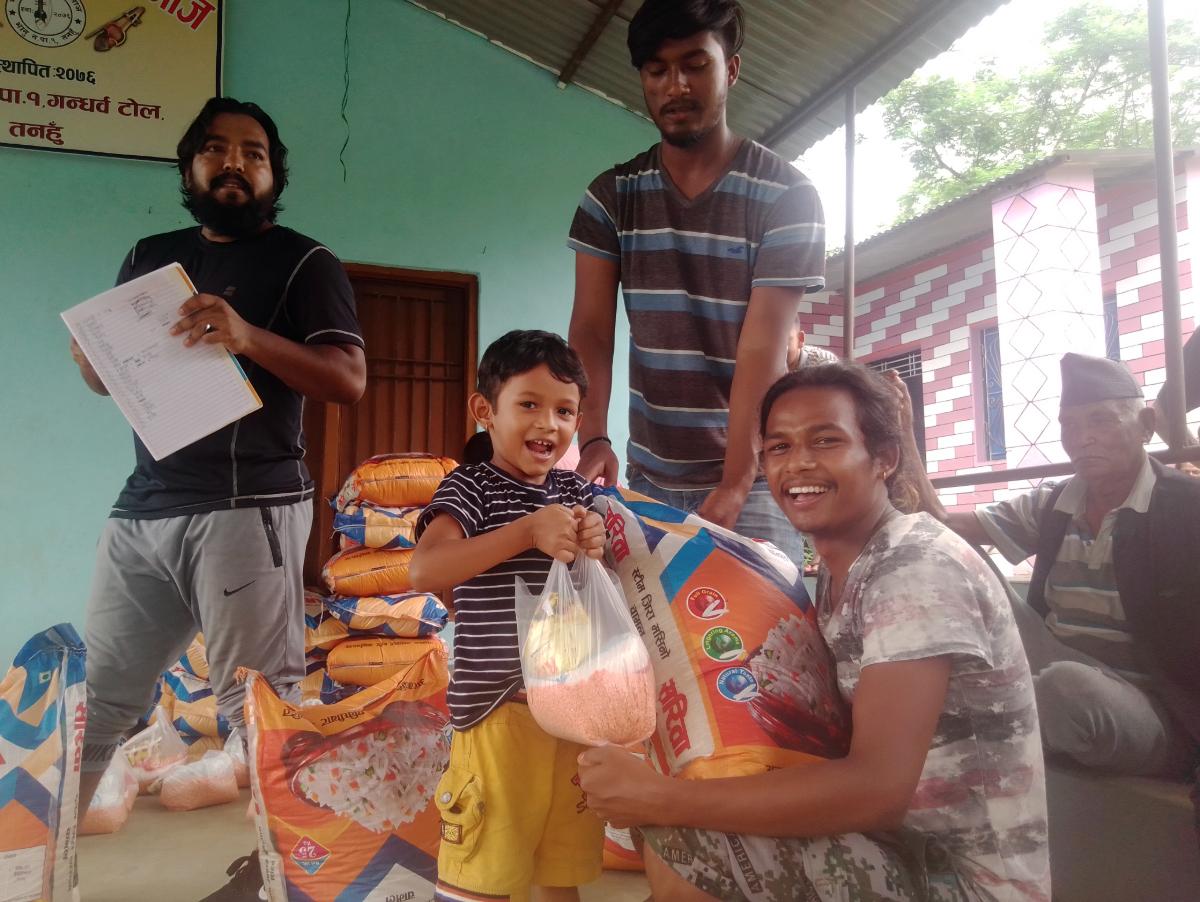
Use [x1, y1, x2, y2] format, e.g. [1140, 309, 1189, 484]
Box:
[72, 97, 366, 898]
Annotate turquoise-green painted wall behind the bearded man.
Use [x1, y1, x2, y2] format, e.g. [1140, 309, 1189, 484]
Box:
[0, 0, 656, 668]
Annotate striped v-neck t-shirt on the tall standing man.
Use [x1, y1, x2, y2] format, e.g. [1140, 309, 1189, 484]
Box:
[568, 140, 824, 488]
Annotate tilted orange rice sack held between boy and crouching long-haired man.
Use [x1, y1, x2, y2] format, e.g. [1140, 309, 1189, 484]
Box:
[595, 489, 850, 778]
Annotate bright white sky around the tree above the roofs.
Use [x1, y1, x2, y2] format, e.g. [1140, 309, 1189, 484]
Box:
[796, 0, 1200, 248]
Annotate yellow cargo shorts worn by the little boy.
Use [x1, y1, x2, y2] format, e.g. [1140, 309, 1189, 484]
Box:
[434, 702, 604, 900]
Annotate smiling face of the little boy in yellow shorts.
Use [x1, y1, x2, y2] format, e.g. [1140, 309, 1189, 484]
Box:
[470, 363, 580, 485]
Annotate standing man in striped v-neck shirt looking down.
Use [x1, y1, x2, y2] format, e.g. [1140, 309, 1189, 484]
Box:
[568, 0, 824, 560]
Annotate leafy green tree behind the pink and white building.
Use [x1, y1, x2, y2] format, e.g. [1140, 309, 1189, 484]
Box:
[882, 0, 1200, 220]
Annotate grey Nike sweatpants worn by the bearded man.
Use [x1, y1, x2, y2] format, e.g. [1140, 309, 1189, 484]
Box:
[83, 501, 312, 771]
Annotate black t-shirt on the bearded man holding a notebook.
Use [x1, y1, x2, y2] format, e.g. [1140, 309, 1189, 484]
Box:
[112, 226, 364, 518]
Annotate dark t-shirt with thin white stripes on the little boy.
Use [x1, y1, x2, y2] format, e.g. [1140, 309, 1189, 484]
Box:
[416, 463, 592, 730]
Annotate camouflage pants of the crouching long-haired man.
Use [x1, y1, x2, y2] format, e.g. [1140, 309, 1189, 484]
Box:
[642, 828, 967, 902]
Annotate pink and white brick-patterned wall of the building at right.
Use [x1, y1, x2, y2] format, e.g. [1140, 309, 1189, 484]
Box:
[802, 158, 1200, 510]
